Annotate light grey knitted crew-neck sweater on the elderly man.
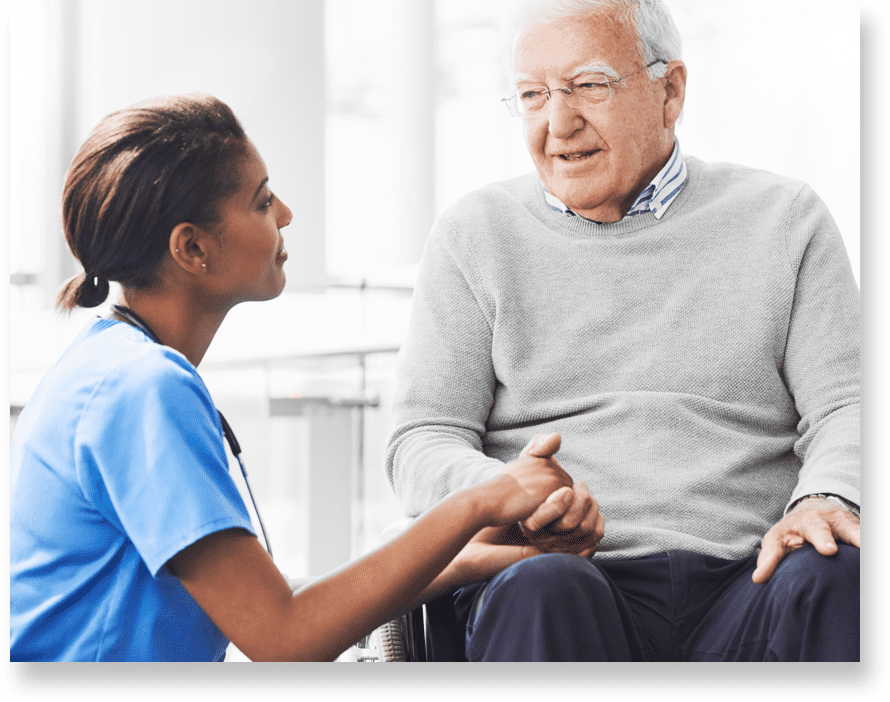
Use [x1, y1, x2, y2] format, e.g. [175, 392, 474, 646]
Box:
[386, 157, 860, 559]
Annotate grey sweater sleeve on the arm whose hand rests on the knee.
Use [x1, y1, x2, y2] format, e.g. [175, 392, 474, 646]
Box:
[783, 185, 860, 513]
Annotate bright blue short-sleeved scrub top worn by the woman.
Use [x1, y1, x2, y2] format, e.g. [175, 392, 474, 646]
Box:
[9, 317, 255, 661]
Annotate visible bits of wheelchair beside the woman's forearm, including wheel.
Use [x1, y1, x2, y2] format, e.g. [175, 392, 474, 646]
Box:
[349, 518, 467, 663]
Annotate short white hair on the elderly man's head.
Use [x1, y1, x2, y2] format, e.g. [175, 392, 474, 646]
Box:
[505, 0, 683, 80]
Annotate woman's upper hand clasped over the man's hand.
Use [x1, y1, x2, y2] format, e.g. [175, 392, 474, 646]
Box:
[480, 434, 572, 526]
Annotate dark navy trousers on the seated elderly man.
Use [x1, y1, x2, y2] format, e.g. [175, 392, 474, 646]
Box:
[454, 543, 859, 662]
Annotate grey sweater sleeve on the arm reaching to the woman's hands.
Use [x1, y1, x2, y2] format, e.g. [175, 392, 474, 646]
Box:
[385, 221, 504, 517]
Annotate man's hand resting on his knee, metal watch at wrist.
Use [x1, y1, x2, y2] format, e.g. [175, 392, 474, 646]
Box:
[752, 498, 859, 583]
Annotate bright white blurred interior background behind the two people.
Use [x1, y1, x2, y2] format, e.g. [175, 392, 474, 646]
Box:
[9, 0, 860, 659]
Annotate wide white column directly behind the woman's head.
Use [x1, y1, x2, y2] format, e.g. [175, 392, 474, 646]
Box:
[76, 0, 326, 285]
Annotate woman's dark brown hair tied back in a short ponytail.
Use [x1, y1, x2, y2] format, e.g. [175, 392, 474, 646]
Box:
[56, 93, 247, 312]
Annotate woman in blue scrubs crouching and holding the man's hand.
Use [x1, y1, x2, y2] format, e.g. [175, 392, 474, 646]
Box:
[9, 94, 584, 661]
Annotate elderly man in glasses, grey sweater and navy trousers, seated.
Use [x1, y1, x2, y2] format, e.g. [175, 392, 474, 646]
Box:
[387, 0, 859, 661]
